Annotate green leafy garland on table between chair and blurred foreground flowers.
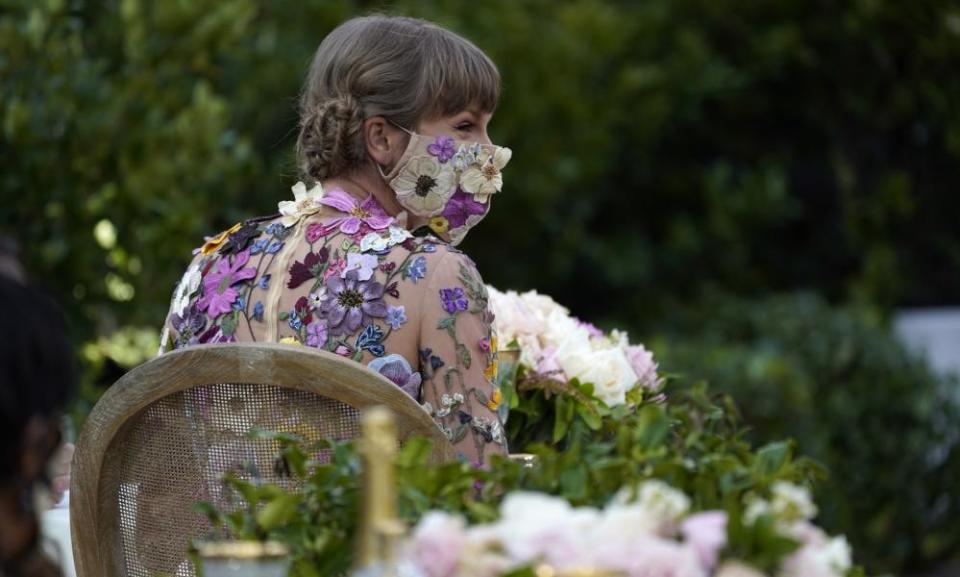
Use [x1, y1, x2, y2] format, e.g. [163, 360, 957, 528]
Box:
[198, 385, 823, 577]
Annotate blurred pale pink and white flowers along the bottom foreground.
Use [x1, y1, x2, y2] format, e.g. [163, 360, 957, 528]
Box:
[403, 480, 855, 577]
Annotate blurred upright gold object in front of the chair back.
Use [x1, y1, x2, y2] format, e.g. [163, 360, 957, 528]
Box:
[354, 407, 406, 575]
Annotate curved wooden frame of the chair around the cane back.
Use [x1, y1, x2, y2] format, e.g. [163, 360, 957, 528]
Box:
[70, 343, 456, 577]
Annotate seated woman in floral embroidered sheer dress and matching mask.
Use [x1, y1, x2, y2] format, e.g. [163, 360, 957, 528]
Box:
[162, 16, 510, 462]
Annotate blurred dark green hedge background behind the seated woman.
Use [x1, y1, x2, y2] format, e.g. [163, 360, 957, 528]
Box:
[0, 0, 960, 574]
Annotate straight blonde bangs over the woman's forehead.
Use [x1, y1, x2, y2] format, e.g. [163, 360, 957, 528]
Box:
[418, 28, 500, 119]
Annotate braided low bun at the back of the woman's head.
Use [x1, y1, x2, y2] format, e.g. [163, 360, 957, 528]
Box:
[297, 95, 365, 181]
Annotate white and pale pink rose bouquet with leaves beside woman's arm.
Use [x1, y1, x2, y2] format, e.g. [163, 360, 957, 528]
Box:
[487, 286, 664, 451]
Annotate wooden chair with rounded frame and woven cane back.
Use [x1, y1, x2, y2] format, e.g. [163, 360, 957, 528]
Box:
[70, 343, 454, 577]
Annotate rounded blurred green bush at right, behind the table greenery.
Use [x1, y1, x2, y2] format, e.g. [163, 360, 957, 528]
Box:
[655, 295, 960, 572]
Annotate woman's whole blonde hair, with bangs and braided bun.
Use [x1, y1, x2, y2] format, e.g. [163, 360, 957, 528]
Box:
[297, 15, 500, 181]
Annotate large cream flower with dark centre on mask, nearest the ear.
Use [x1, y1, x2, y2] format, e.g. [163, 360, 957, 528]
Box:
[390, 156, 456, 216]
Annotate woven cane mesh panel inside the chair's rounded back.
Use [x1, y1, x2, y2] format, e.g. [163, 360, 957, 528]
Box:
[108, 384, 359, 577]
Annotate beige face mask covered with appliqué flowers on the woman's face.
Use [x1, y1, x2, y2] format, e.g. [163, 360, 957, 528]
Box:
[381, 127, 513, 245]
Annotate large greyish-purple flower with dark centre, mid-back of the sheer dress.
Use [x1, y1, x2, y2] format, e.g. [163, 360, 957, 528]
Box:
[318, 271, 387, 335]
